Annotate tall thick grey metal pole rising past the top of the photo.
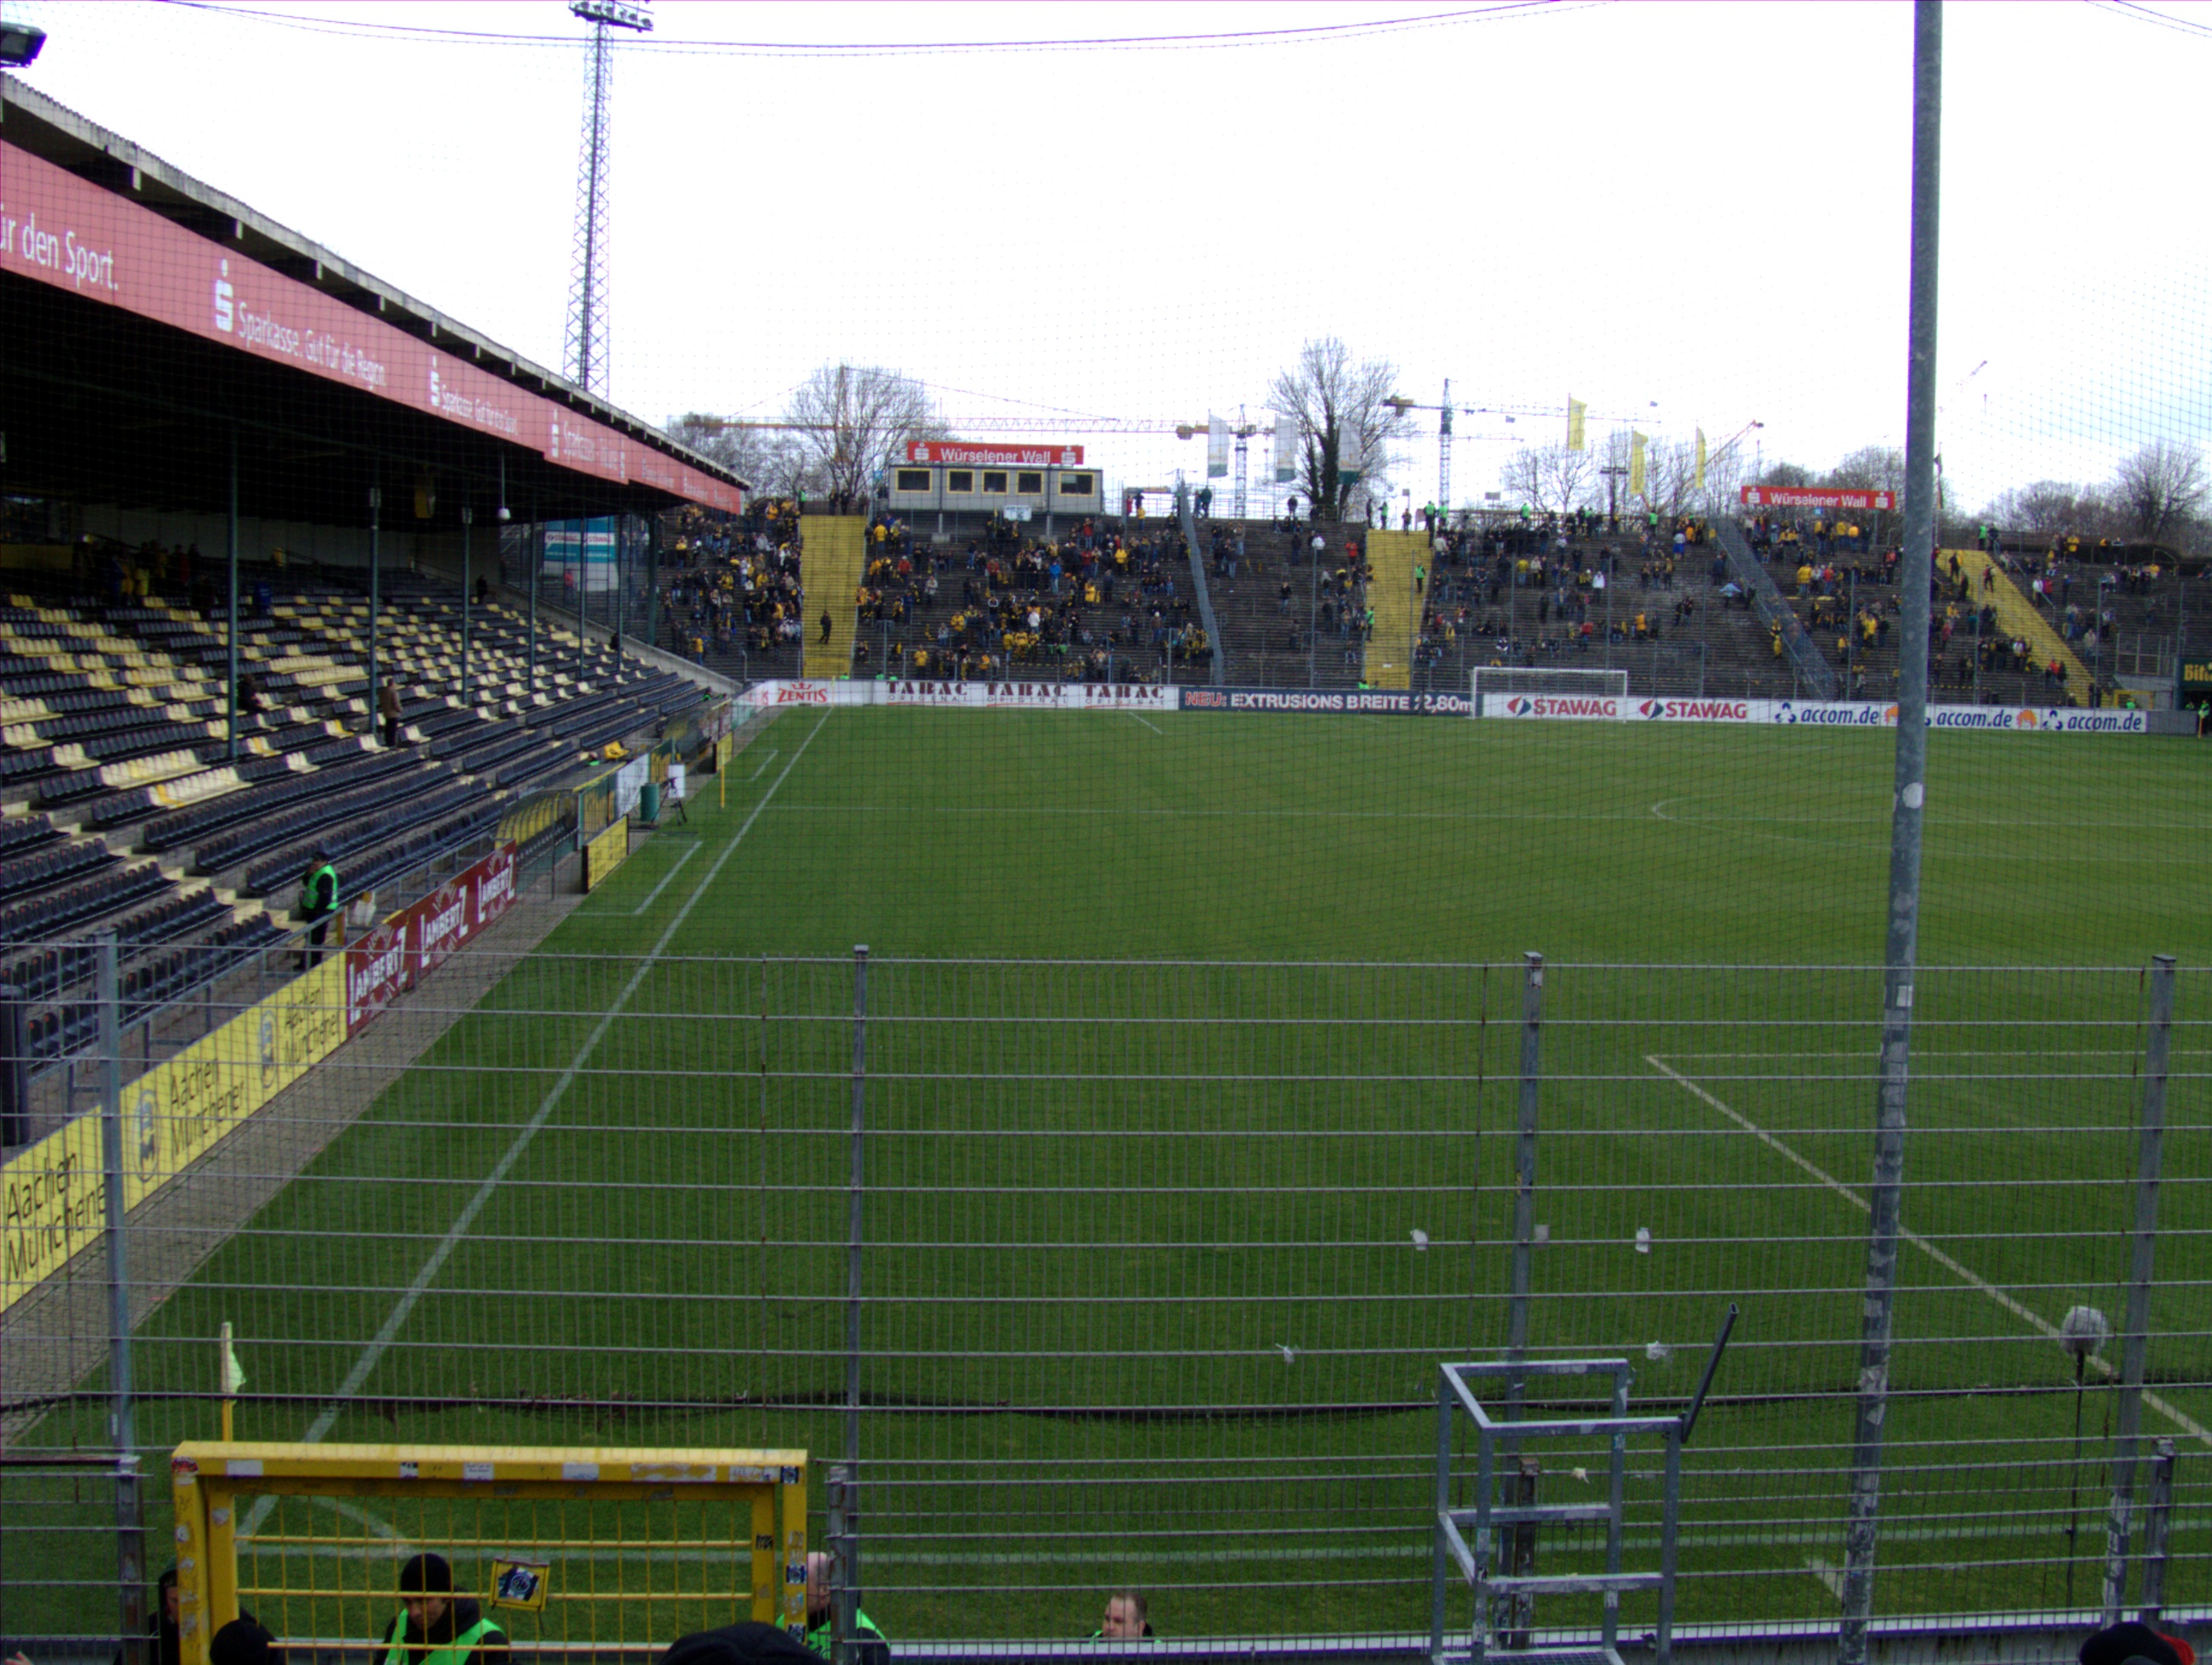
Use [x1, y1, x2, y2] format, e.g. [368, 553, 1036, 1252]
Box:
[1836, 0, 1942, 1665]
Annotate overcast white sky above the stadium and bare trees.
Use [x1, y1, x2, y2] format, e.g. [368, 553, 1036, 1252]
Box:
[4, 0, 2212, 502]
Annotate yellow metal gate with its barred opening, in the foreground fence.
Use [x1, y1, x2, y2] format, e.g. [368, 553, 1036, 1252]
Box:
[171, 1439, 807, 1665]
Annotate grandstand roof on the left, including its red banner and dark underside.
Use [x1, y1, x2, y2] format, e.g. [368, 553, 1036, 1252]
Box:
[0, 77, 748, 524]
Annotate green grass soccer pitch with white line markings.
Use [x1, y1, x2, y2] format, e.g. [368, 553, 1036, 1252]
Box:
[17, 708, 2212, 1636]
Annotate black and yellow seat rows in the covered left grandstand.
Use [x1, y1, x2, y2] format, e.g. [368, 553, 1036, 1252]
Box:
[0, 552, 699, 1083]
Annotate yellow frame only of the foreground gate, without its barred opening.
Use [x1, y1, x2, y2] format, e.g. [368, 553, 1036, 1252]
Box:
[171, 1439, 807, 1665]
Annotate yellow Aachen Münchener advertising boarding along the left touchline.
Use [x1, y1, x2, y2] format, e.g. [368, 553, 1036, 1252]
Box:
[0, 956, 345, 1311]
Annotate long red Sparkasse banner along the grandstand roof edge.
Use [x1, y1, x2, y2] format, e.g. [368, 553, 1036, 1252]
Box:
[0, 143, 741, 513]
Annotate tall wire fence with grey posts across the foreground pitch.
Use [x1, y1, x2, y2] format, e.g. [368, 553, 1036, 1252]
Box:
[0, 955, 2212, 1647]
